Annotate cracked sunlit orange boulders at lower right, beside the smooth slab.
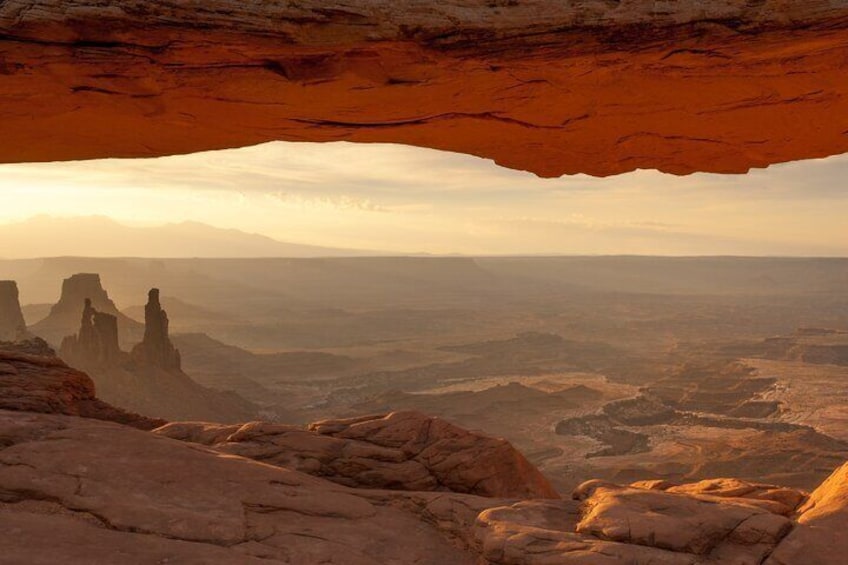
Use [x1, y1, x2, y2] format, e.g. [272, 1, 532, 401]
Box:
[476, 479, 812, 565]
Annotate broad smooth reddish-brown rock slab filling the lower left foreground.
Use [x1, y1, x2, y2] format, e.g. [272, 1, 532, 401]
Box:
[0, 411, 494, 565]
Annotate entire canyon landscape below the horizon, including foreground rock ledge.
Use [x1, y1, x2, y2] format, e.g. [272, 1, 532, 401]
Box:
[0, 258, 848, 565]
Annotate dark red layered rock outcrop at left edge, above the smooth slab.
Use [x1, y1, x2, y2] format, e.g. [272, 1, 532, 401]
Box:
[0, 340, 164, 428]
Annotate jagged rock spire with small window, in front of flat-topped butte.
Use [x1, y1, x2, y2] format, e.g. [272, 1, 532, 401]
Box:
[60, 298, 124, 367]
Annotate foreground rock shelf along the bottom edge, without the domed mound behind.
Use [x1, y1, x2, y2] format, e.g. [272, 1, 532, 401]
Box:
[0, 410, 848, 565]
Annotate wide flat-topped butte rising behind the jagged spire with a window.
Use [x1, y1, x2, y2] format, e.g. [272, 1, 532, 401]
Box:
[31, 273, 141, 345]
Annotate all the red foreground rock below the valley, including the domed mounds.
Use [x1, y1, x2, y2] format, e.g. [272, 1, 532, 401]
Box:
[0, 342, 848, 565]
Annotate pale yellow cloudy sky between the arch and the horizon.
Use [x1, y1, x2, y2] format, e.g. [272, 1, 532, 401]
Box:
[0, 142, 848, 256]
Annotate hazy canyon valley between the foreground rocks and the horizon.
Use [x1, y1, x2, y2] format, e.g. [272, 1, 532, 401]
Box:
[0, 257, 848, 492]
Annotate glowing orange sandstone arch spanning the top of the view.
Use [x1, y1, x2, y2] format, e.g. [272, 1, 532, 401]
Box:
[0, 0, 848, 176]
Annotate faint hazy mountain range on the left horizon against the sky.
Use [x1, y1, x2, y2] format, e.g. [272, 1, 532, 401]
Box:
[0, 216, 385, 259]
